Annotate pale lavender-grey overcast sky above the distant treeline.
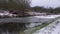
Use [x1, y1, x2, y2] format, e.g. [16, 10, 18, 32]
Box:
[31, 0, 60, 8]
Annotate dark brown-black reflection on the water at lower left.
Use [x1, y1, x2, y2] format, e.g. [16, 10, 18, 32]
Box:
[0, 23, 25, 34]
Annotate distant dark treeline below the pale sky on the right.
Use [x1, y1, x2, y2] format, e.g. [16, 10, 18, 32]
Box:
[31, 6, 60, 14]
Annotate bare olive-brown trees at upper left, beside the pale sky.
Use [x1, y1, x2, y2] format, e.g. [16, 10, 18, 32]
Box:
[0, 0, 30, 16]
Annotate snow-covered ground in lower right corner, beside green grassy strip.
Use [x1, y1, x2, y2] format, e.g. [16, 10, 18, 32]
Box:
[33, 19, 60, 34]
